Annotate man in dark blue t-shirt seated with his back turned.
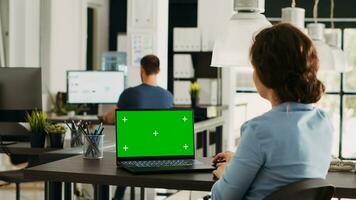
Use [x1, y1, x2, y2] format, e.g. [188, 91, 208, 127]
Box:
[103, 55, 173, 200]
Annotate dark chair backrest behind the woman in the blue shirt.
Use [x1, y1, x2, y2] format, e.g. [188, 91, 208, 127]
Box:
[265, 179, 335, 200]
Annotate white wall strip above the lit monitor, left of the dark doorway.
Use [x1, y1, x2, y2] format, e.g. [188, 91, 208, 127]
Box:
[44, 0, 85, 93]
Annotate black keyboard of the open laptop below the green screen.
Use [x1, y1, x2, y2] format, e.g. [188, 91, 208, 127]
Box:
[121, 159, 194, 168]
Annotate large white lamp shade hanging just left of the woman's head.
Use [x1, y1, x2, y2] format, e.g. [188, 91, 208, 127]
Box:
[211, 13, 271, 68]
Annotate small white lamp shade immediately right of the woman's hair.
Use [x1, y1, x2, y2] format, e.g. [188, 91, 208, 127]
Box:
[314, 40, 335, 71]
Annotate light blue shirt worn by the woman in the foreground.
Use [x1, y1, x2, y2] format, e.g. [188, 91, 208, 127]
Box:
[212, 103, 333, 200]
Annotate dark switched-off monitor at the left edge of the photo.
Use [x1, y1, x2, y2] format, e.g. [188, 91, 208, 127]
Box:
[0, 67, 42, 122]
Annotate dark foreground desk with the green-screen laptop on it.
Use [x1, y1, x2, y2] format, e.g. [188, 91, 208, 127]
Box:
[25, 152, 356, 198]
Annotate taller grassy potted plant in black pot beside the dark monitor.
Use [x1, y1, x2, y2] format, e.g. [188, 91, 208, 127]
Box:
[26, 110, 47, 148]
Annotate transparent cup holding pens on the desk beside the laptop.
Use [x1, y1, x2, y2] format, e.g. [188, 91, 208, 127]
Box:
[83, 135, 104, 159]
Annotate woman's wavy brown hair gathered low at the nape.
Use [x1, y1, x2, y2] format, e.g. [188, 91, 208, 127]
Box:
[250, 23, 325, 103]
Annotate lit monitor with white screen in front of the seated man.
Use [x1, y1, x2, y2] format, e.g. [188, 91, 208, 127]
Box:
[67, 71, 125, 104]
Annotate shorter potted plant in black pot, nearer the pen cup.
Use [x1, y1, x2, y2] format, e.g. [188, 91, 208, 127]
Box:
[45, 124, 67, 148]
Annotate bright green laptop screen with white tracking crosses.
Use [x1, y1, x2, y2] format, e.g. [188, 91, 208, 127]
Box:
[116, 110, 194, 158]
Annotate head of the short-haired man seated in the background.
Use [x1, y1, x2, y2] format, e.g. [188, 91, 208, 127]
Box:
[141, 55, 159, 81]
